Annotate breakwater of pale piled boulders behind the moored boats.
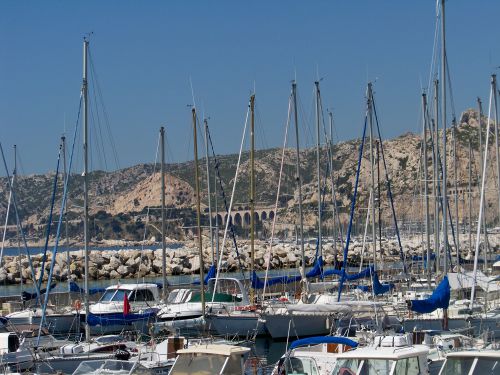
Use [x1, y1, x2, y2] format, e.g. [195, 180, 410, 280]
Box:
[0, 235, 500, 285]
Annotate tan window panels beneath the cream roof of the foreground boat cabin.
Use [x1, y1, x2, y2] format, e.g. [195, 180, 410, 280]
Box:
[170, 353, 227, 375]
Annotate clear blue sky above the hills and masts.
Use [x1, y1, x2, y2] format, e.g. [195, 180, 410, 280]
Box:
[0, 0, 500, 175]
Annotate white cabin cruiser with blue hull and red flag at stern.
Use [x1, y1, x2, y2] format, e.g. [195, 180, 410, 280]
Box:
[74, 283, 160, 334]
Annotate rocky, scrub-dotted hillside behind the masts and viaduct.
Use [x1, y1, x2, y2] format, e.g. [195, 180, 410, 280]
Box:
[0, 110, 498, 241]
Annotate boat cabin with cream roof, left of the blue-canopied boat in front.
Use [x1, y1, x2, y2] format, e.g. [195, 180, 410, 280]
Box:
[170, 344, 250, 375]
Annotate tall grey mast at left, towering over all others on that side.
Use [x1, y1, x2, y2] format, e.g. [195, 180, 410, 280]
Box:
[82, 38, 90, 342]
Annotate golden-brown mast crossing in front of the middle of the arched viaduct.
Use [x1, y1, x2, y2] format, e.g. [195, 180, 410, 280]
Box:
[250, 94, 255, 305]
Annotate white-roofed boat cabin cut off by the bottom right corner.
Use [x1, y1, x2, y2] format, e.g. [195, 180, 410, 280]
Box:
[439, 350, 500, 375]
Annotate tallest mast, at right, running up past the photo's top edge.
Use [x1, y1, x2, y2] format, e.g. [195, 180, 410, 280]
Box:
[441, 0, 448, 275]
